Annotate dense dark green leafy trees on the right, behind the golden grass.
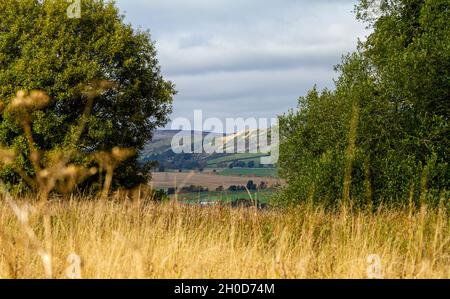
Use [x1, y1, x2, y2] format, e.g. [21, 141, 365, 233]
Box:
[277, 0, 450, 206]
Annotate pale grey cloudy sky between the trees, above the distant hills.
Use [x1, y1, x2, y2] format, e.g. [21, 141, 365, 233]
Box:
[117, 0, 367, 128]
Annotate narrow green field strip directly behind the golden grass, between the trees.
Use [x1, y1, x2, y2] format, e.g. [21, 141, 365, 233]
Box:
[174, 190, 273, 203]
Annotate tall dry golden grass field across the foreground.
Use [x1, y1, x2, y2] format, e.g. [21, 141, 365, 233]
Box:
[0, 198, 450, 278]
